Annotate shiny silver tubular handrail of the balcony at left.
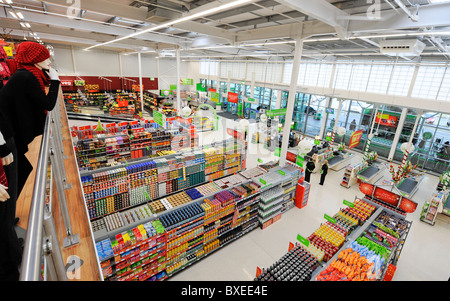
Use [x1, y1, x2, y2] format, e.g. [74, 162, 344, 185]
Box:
[19, 112, 52, 281]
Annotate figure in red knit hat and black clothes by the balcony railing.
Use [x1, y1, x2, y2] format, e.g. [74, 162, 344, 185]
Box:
[0, 41, 60, 280]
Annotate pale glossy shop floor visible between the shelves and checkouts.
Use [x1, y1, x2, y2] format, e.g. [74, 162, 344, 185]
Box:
[168, 115, 450, 281]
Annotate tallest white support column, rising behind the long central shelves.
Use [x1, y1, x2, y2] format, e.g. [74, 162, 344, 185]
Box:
[279, 30, 303, 166]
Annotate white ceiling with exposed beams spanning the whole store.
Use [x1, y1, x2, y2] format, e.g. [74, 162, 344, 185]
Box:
[0, 0, 450, 60]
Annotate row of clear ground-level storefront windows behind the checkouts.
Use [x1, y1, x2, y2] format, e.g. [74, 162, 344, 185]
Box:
[201, 80, 450, 174]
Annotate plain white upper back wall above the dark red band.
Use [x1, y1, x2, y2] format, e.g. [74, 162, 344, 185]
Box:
[53, 45, 200, 91]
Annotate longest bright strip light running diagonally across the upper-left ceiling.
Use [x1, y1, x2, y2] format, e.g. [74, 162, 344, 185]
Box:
[84, 0, 252, 50]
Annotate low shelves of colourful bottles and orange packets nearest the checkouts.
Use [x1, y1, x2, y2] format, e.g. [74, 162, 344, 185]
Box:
[255, 185, 411, 281]
